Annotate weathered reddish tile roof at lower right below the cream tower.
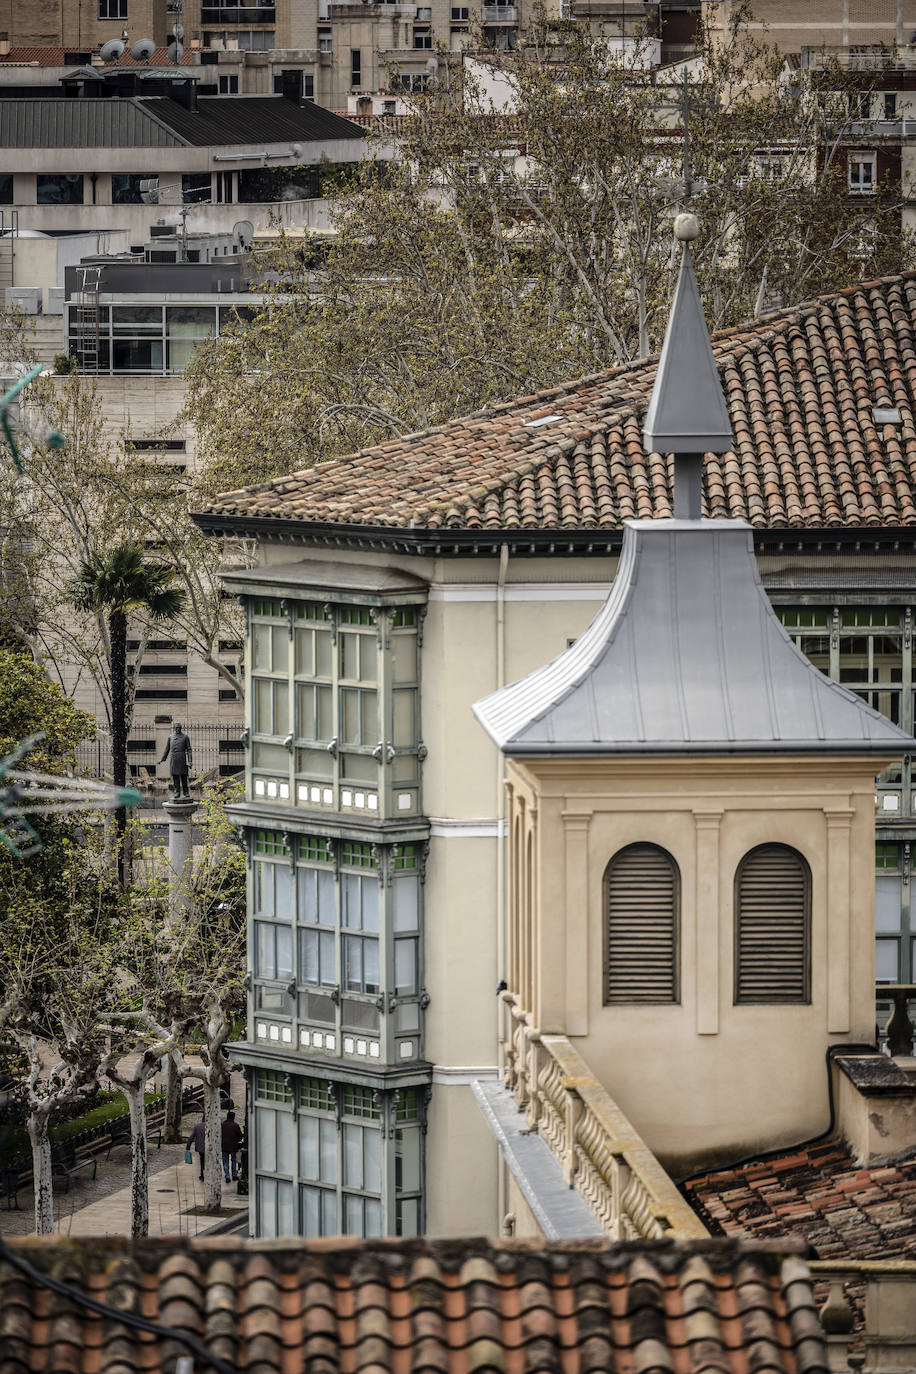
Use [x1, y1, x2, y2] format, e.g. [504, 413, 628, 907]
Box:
[684, 1140, 916, 1260]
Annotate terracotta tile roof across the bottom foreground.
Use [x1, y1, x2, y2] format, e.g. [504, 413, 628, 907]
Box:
[0, 1237, 827, 1374]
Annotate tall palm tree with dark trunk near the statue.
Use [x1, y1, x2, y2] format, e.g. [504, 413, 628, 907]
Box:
[69, 543, 184, 886]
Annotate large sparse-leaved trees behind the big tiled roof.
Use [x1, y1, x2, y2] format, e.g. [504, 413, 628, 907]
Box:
[187, 7, 912, 499]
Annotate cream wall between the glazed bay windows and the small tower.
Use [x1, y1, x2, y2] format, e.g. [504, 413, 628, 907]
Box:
[252, 544, 615, 1235]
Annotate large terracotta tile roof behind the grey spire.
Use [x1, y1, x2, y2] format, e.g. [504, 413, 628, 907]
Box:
[199, 272, 916, 530]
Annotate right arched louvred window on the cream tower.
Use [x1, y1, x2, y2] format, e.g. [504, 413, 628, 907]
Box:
[735, 845, 812, 1002]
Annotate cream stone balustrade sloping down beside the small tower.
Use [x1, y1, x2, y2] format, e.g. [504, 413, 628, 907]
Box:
[504, 993, 707, 1241]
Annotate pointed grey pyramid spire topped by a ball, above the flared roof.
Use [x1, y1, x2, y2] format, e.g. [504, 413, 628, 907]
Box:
[643, 236, 732, 453]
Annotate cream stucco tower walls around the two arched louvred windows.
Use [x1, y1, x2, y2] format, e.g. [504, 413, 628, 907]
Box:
[508, 756, 882, 1175]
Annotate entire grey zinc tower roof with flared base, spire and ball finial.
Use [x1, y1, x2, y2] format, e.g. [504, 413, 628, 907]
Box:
[474, 216, 916, 758]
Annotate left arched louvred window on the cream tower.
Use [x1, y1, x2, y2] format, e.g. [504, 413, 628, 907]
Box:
[604, 844, 680, 1006]
